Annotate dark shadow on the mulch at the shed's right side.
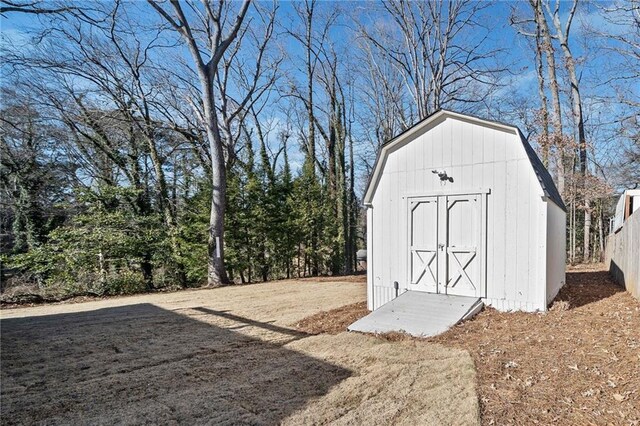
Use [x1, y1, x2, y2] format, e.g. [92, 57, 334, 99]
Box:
[553, 271, 624, 309]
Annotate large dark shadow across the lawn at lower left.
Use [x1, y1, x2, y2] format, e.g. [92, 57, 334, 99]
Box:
[0, 304, 352, 424]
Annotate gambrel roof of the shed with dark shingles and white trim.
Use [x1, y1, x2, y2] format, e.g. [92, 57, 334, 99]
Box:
[364, 109, 567, 212]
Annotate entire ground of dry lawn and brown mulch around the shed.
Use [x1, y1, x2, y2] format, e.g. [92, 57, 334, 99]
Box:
[0, 265, 640, 425]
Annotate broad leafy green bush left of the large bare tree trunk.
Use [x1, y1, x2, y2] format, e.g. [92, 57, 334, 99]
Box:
[8, 187, 166, 295]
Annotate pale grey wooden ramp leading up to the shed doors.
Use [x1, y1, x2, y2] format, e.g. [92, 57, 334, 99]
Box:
[348, 291, 483, 337]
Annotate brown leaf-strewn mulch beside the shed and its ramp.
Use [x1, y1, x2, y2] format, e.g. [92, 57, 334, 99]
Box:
[300, 265, 640, 425]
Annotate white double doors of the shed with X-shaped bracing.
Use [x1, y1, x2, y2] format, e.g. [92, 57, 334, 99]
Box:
[408, 194, 486, 297]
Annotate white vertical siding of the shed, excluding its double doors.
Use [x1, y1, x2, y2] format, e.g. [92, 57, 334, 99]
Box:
[367, 115, 565, 311]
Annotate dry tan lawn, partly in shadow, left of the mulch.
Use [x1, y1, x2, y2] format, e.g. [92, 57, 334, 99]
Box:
[0, 277, 479, 425]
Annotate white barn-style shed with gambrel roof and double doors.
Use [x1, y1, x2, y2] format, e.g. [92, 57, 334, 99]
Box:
[364, 110, 566, 311]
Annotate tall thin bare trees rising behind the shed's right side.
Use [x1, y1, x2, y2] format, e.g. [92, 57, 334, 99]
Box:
[510, 0, 640, 263]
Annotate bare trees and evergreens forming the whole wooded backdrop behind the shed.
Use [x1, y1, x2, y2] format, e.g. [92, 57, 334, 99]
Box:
[0, 0, 640, 294]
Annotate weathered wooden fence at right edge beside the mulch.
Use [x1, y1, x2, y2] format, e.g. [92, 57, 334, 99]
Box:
[605, 210, 640, 299]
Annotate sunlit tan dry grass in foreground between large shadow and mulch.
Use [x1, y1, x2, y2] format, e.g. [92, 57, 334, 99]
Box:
[284, 332, 479, 426]
